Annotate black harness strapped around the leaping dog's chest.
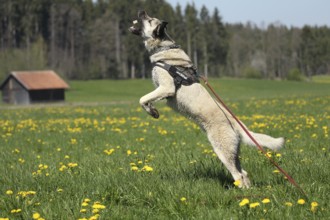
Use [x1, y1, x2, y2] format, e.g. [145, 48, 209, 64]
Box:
[154, 62, 199, 89]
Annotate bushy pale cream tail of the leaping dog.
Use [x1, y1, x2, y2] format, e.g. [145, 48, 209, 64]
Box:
[238, 123, 285, 150]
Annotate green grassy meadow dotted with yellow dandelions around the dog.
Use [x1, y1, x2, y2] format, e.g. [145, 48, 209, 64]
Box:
[0, 79, 330, 220]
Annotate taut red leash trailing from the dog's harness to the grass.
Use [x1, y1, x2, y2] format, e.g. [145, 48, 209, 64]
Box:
[200, 76, 307, 197]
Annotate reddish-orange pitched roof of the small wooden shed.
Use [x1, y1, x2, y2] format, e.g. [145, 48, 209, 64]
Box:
[0, 70, 69, 90]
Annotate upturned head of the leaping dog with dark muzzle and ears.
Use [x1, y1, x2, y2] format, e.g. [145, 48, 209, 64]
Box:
[129, 11, 167, 40]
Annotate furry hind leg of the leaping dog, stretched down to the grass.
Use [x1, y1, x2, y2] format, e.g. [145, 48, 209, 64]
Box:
[208, 130, 250, 188]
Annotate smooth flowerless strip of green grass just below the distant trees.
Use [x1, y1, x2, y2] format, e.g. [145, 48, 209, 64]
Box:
[66, 79, 329, 102]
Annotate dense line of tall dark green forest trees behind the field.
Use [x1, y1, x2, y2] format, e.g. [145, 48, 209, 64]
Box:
[0, 0, 330, 80]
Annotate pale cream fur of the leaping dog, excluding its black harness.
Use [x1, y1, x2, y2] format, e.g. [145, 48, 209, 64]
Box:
[131, 12, 284, 187]
